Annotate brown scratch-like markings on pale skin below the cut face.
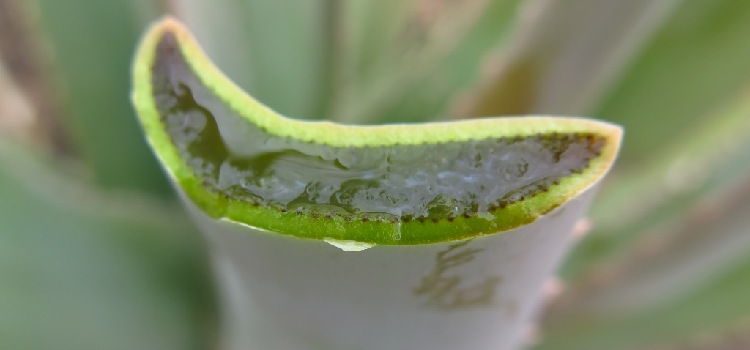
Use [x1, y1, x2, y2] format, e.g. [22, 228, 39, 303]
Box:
[413, 240, 501, 311]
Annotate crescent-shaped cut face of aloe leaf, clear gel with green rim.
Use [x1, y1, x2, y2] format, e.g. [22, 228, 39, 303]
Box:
[133, 20, 620, 245]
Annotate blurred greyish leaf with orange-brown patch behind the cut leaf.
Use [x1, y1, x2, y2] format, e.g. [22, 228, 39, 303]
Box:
[458, 0, 677, 117]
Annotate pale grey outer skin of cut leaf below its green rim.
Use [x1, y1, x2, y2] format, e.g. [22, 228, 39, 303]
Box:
[186, 189, 593, 350]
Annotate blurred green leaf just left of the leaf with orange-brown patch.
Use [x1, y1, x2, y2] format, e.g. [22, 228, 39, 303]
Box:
[336, 0, 528, 124]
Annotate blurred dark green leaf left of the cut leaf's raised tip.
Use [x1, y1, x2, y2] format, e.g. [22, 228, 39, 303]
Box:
[29, 0, 169, 195]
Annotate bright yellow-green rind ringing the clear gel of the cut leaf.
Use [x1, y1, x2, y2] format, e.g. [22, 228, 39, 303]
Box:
[132, 17, 622, 245]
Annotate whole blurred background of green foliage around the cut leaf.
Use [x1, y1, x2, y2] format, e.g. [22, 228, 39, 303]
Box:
[0, 0, 750, 350]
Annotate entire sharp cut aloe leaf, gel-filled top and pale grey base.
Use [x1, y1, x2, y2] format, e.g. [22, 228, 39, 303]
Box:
[133, 19, 621, 350]
